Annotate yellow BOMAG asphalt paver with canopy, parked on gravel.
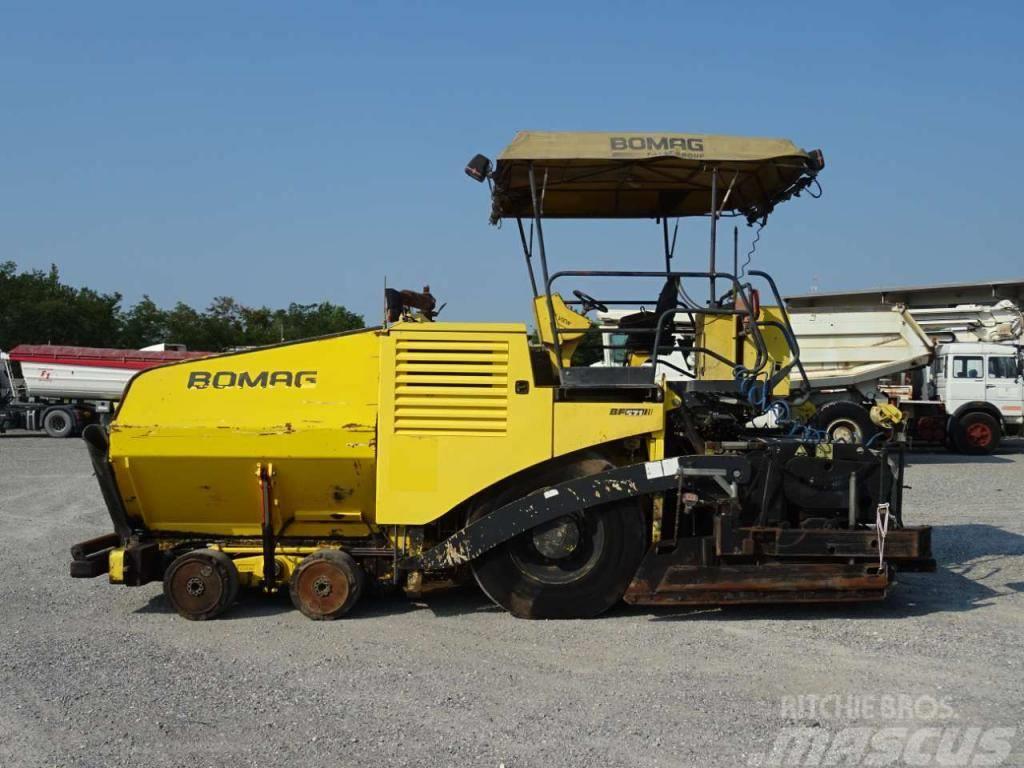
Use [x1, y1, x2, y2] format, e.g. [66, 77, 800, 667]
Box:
[71, 131, 935, 620]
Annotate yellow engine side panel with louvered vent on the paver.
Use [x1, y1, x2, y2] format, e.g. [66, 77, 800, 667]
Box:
[377, 323, 553, 525]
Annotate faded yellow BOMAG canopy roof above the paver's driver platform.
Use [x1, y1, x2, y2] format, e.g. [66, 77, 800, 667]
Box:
[490, 131, 823, 222]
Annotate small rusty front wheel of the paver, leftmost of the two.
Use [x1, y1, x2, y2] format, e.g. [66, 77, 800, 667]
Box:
[164, 549, 239, 622]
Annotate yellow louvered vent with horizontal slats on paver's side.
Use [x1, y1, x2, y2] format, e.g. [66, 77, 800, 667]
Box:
[394, 339, 509, 435]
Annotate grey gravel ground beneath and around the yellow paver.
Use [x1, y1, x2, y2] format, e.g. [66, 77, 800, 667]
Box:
[0, 434, 1024, 768]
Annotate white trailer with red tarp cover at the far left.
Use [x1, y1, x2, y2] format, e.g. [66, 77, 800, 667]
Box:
[0, 344, 206, 437]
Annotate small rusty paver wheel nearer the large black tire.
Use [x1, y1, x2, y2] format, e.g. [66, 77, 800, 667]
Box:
[289, 549, 367, 621]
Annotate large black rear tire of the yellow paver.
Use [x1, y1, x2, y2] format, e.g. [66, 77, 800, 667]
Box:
[470, 461, 646, 618]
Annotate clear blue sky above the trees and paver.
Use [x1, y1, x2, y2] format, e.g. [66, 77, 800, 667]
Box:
[0, 0, 1024, 322]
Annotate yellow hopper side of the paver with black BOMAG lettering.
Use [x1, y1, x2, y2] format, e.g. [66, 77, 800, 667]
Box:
[111, 331, 380, 536]
